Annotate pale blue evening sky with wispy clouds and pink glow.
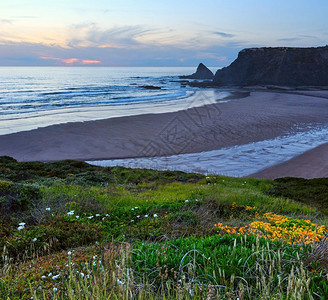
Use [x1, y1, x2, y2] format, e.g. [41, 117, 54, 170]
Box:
[0, 0, 328, 67]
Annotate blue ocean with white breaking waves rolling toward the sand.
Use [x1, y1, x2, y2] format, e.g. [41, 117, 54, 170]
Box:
[0, 67, 220, 134]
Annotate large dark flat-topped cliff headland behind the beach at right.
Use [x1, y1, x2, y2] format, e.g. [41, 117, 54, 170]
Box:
[213, 46, 328, 87]
